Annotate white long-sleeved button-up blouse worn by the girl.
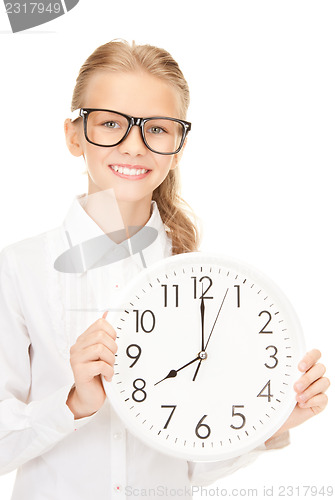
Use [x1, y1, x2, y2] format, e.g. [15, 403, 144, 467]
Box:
[0, 195, 288, 500]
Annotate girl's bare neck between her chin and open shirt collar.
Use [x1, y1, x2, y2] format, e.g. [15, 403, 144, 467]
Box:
[84, 189, 151, 243]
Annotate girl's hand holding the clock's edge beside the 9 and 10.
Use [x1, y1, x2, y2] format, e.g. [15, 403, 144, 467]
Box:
[66, 312, 117, 419]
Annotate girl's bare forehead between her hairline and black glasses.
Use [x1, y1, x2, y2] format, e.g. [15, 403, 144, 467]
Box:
[82, 71, 180, 118]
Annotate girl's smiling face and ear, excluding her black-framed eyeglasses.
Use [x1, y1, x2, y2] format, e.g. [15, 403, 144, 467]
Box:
[65, 72, 184, 209]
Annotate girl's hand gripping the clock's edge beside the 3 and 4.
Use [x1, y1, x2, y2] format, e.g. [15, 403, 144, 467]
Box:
[271, 349, 330, 439]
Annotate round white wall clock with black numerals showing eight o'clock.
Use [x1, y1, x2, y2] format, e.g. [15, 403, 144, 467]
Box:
[103, 253, 304, 461]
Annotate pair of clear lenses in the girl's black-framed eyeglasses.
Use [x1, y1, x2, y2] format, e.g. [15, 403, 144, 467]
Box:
[87, 111, 184, 153]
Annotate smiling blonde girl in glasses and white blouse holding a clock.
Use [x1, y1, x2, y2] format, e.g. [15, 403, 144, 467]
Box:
[0, 41, 329, 500]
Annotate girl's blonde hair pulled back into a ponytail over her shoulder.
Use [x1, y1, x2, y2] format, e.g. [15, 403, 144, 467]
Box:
[71, 40, 200, 254]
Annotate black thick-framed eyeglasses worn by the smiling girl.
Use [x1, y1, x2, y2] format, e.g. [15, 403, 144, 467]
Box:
[71, 108, 191, 155]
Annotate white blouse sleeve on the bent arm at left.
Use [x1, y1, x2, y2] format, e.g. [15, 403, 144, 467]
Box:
[0, 247, 94, 474]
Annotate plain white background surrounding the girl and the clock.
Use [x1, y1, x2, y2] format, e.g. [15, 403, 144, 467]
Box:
[0, 0, 335, 500]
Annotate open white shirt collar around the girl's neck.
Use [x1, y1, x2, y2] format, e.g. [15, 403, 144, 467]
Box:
[55, 194, 171, 274]
